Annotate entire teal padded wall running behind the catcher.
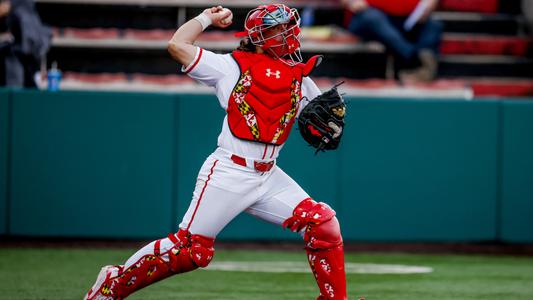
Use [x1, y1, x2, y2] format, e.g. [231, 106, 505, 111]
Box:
[0, 91, 533, 243]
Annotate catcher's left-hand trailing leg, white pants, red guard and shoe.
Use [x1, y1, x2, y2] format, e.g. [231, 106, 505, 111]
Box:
[85, 159, 260, 300]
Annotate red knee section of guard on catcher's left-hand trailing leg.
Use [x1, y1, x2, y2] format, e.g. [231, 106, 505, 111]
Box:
[168, 229, 215, 268]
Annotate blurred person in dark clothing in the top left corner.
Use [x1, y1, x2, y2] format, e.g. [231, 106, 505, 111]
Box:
[0, 0, 52, 87]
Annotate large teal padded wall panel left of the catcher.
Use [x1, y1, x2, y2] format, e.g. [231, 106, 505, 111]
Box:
[10, 91, 175, 238]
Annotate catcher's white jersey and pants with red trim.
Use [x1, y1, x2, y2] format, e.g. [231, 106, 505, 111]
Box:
[180, 48, 321, 238]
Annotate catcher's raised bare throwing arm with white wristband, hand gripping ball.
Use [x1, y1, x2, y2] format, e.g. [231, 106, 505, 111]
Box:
[167, 6, 232, 66]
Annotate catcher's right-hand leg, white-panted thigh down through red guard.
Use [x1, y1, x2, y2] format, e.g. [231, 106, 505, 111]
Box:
[247, 167, 347, 299]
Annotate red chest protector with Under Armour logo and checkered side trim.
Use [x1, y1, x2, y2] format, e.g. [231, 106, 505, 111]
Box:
[227, 51, 322, 145]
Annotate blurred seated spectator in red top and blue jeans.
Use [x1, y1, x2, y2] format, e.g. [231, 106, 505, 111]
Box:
[342, 0, 443, 82]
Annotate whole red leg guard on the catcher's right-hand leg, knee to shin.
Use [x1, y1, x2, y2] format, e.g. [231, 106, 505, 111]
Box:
[283, 199, 348, 300]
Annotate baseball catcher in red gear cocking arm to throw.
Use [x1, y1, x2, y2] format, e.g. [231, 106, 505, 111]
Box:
[84, 4, 354, 300]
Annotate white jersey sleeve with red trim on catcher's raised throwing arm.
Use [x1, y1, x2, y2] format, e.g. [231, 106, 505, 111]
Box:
[182, 47, 234, 87]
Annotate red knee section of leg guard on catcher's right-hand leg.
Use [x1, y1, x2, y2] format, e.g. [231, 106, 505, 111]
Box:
[283, 198, 342, 249]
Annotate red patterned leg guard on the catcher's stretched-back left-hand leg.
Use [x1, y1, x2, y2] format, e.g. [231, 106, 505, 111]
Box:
[92, 229, 215, 299]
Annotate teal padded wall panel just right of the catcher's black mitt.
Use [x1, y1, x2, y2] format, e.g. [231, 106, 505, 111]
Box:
[339, 99, 499, 241]
